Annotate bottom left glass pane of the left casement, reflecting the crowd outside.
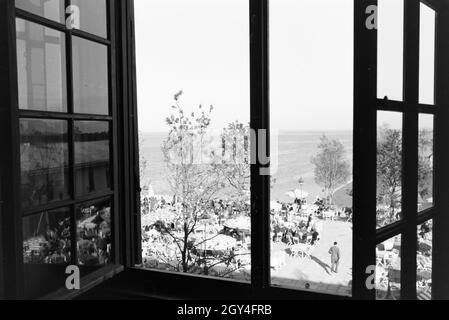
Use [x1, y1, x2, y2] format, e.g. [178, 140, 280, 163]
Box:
[22, 208, 71, 264]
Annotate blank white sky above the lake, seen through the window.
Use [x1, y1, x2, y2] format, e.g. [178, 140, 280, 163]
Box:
[135, 0, 433, 132]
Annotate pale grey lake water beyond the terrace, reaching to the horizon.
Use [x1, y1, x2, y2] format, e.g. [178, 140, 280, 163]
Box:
[140, 131, 353, 201]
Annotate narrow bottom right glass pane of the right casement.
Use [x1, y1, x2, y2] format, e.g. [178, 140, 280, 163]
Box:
[416, 220, 433, 300]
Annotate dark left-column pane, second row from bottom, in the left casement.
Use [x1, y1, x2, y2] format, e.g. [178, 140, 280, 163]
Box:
[20, 119, 69, 207]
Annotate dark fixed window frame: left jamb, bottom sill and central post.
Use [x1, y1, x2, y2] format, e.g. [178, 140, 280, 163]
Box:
[122, 0, 350, 299]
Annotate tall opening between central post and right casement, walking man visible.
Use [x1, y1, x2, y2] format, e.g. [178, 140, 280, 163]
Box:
[269, 0, 354, 296]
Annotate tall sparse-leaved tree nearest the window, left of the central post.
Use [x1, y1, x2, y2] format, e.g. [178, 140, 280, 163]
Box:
[151, 91, 248, 274]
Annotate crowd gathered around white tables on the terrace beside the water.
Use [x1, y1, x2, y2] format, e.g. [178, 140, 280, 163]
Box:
[141, 192, 350, 275]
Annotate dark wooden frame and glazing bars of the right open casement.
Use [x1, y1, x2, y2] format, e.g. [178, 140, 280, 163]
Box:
[354, 0, 449, 300]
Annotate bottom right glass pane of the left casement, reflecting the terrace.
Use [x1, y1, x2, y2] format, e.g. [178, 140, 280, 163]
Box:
[76, 200, 112, 267]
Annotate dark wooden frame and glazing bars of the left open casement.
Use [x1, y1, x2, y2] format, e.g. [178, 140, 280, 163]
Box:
[0, 0, 123, 299]
